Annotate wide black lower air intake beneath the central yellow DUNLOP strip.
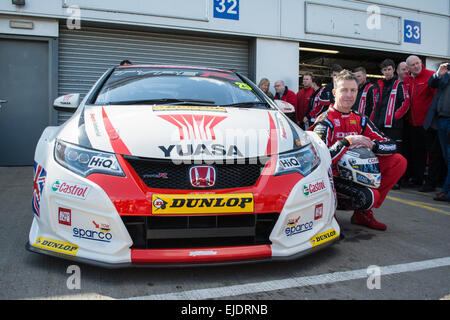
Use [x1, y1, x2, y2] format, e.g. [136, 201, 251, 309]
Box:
[122, 213, 279, 249]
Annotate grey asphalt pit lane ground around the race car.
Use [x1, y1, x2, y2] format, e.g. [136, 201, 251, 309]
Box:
[0, 167, 450, 300]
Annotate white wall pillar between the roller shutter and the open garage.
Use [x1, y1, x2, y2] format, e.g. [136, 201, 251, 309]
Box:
[255, 38, 299, 95]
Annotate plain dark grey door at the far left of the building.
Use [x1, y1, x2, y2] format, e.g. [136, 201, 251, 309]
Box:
[0, 39, 49, 166]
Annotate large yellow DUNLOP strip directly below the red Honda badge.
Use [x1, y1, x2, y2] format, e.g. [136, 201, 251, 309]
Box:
[152, 193, 254, 214]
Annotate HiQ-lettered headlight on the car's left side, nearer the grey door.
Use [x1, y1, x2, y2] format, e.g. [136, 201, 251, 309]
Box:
[54, 140, 125, 177]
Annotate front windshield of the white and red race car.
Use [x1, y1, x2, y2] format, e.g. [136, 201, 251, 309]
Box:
[94, 67, 267, 108]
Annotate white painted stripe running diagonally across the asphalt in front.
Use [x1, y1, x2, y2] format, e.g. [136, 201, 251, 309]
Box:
[128, 257, 450, 300]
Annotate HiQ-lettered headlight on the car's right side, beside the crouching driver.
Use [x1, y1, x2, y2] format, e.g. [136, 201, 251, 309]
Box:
[275, 143, 320, 177]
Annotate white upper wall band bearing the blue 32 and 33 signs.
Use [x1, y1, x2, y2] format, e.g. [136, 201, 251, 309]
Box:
[0, 0, 450, 58]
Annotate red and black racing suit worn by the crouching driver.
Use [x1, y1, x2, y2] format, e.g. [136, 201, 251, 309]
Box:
[310, 105, 407, 229]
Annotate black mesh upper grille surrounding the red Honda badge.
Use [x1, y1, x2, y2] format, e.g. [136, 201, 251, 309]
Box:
[125, 157, 264, 190]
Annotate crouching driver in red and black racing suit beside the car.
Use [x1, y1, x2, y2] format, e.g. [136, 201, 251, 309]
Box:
[312, 70, 406, 230]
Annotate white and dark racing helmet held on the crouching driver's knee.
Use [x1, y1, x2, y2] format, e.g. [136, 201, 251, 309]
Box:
[337, 148, 381, 189]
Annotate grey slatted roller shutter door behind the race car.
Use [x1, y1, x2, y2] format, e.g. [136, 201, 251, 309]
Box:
[58, 25, 249, 124]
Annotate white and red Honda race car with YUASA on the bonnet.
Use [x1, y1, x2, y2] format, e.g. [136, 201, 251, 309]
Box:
[26, 65, 340, 267]
